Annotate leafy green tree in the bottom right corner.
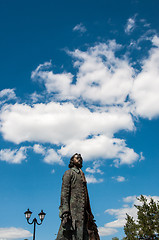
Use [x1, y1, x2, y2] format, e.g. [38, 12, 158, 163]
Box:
[124, 195, 159, 240]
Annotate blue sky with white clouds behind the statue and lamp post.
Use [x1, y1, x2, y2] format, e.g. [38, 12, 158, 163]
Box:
[0, 0, 159, 240]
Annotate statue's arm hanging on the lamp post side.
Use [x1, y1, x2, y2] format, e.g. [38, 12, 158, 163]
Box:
[59, 170, 71, 218]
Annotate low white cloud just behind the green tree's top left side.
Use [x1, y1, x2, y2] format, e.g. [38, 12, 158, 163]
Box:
[99, 196, 159, 236]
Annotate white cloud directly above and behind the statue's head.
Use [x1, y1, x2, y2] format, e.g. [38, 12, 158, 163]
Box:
[59, 135, 139, 166]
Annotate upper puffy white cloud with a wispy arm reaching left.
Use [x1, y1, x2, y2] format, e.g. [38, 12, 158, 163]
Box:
[32, 40, 133, 105]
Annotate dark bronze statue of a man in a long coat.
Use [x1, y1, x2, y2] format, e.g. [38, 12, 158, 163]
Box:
[56, 153, 100, 240]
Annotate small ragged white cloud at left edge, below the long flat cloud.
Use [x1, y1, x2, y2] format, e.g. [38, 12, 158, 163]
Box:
[0, 147, 27, 164]
